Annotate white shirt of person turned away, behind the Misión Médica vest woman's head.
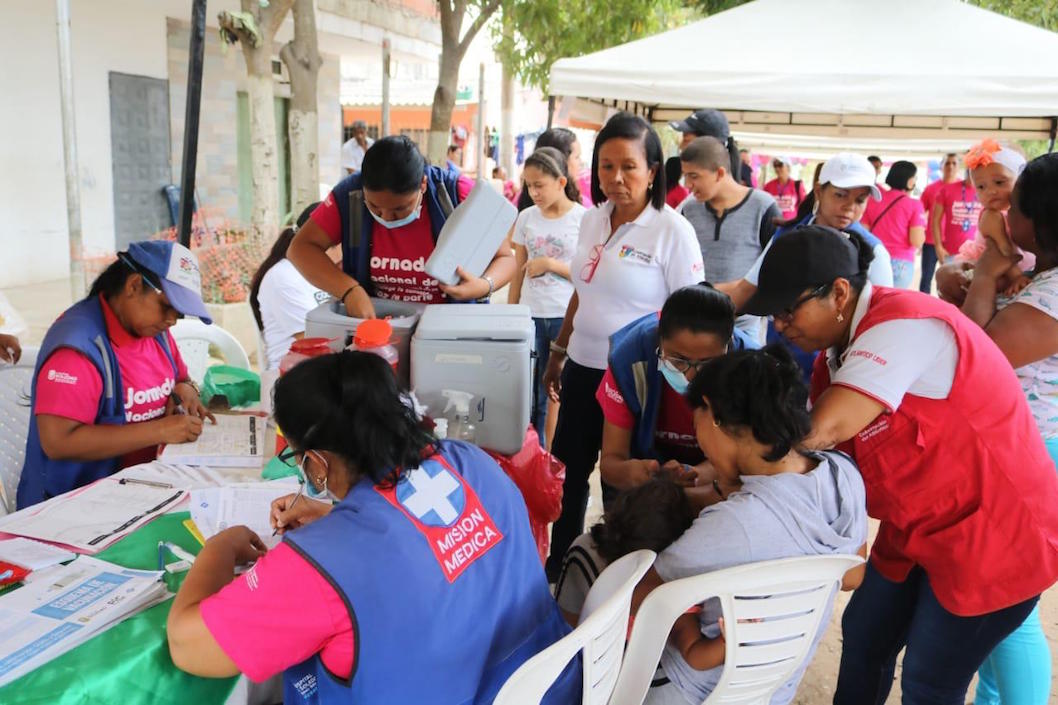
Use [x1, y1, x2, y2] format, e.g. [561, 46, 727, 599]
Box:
[257, 258, 328, 369]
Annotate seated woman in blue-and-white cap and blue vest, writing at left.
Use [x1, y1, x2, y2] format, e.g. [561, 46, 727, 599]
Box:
[17, 240, 215, 509]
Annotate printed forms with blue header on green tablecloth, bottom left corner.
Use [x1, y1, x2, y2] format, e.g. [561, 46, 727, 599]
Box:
[0, 556, 168, 686]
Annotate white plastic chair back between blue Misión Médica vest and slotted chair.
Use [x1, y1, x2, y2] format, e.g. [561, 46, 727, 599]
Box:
[493, 550, 657, 705]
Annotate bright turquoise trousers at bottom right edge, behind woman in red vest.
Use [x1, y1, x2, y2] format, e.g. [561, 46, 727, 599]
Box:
[973, 438, 1058, 705]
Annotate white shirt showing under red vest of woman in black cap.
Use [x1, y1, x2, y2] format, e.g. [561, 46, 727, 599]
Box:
[826, 283, 959, 412]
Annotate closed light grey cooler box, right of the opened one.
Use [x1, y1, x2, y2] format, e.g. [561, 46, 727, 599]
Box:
[412, 304, 535, 454]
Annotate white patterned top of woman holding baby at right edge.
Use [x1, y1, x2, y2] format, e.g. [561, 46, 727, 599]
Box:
[997, 269, 1058, 439]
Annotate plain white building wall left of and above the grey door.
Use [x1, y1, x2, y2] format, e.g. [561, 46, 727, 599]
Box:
[0, 0, 166, 286]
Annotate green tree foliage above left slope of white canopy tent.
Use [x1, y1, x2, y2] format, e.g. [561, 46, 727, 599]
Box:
[493, 0, 699, 93]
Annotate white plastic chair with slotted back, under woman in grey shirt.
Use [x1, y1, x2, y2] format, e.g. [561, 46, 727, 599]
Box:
[609, 555, 863, 705]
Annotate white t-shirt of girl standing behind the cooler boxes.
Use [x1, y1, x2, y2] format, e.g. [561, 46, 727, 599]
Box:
[511, 203, 587, 319]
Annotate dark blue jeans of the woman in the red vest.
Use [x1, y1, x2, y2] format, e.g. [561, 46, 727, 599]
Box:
[834, 563, 1039, 705]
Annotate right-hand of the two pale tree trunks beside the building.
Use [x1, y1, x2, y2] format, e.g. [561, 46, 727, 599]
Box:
[279, 0, 323, 217]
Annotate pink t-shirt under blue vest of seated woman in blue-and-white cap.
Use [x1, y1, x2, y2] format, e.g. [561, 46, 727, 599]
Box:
[33, 296, 187, 467]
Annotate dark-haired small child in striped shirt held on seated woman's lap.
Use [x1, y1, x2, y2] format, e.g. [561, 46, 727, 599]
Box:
[554, 472, 695, 626]
